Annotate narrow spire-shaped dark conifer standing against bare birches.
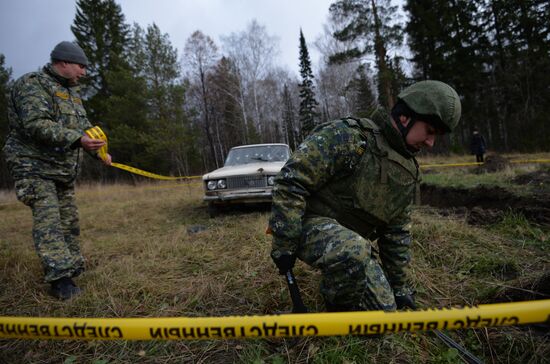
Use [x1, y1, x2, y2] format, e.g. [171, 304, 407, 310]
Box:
[299, 29, 319, 139]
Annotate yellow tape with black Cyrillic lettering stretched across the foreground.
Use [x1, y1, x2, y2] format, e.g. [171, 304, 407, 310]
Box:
[0, 300, 550, 340]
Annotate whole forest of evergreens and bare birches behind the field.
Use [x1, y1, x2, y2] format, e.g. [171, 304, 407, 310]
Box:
[0, 0, 550, 188]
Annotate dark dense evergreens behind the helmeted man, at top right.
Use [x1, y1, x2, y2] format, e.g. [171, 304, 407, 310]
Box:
[405, 0, 550, 151]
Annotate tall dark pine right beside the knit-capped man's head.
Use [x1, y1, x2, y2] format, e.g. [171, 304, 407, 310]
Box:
[71, 0, 152, 178]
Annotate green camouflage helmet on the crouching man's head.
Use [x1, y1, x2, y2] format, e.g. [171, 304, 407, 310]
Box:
[397, 80, 462, 133]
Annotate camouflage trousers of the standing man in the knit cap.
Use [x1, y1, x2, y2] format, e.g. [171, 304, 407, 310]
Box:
[15, 177, 84, 282]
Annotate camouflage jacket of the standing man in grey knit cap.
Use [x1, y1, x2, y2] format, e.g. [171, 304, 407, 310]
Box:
[3, 65, 91, 182]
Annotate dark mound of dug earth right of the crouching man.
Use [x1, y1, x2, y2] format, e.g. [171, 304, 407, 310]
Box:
[420, 184, 550, 225]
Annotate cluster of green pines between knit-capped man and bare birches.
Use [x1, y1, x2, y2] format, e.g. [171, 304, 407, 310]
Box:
[71, 0, 204, 178]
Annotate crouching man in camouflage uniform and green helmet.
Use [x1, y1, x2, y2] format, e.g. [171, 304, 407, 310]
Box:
[269, 81, 461, 311]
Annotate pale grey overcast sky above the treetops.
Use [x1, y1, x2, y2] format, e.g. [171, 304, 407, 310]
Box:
[0, 0, 340, 78]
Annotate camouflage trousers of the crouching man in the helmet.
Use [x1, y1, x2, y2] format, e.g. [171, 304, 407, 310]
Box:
[296, 217, 396, 311]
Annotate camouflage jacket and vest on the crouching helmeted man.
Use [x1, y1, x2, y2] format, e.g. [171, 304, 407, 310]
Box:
[270, 111, 419, 289]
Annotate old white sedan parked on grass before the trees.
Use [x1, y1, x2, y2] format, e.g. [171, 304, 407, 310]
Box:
[202, 143, 290, 217]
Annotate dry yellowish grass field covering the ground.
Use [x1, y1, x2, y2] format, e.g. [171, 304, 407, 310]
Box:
[0, 152, 550, 364]
